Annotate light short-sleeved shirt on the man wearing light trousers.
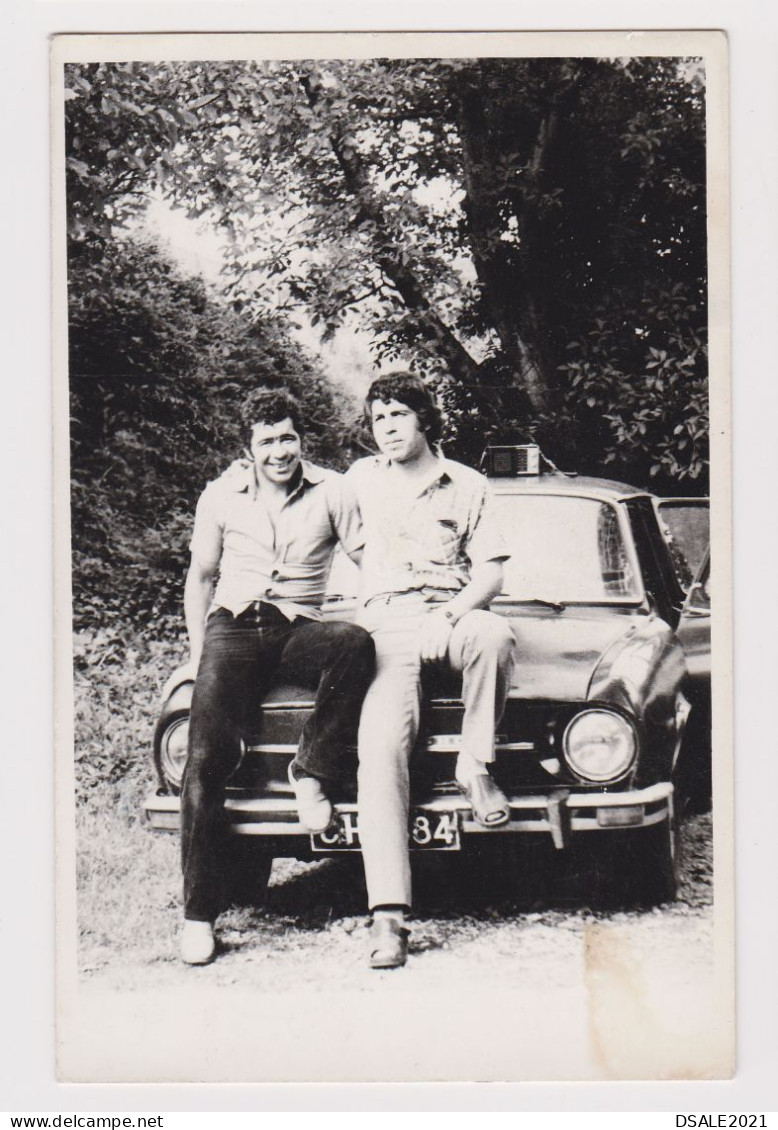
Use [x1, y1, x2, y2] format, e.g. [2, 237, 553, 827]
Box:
[345, 455, 510, 603]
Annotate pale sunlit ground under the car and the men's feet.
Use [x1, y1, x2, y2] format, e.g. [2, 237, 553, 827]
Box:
[83, 816, 712, 991]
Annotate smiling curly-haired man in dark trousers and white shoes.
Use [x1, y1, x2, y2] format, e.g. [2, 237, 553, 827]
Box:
[181, 390, 374, 965]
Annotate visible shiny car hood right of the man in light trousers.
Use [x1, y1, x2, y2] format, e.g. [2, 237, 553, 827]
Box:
[502, 607, 648, 702]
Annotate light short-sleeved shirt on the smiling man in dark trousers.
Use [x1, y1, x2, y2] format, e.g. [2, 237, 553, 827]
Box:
[190, 461, 364, 619]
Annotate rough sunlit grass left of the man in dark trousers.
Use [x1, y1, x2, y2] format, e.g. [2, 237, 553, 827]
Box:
[74, 631, 184, 970]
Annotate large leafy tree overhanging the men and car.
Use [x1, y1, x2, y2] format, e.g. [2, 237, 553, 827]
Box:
[67, 59, 707, 483]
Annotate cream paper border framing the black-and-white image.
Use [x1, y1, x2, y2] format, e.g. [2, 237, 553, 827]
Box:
[52, 24, 734, 1083]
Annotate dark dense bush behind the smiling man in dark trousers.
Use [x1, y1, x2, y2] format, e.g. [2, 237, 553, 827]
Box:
[69, 238, 355, 638]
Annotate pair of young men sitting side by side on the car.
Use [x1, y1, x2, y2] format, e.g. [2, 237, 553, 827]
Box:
[182, 374, 513, 968]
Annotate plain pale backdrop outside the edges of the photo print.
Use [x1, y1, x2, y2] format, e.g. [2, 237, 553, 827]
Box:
[3, 2, 776, 1110]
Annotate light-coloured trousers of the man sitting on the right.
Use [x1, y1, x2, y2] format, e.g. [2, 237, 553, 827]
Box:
[358, 593, 515, 907]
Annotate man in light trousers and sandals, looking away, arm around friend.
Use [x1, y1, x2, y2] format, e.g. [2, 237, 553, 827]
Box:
[346, 373, 515, 968]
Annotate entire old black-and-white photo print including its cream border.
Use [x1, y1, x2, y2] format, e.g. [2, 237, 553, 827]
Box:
[52, 33, 734, 1083]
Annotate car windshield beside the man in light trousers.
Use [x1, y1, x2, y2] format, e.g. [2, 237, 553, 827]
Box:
[495, 495, 642, 605]
